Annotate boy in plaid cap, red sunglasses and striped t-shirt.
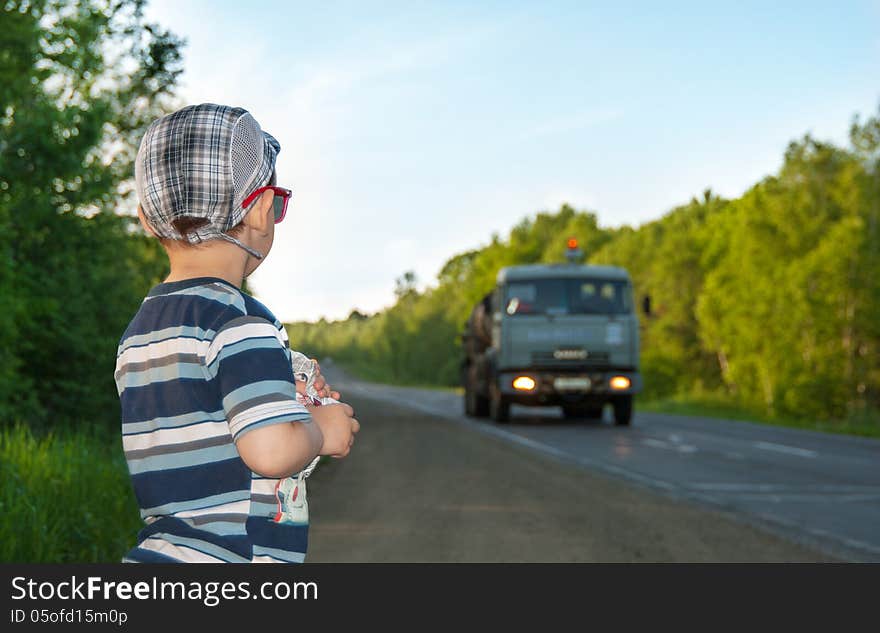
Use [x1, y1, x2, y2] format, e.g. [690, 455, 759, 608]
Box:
[114, 103, 360, 562]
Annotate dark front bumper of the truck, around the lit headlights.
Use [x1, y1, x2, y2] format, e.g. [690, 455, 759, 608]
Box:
[498, 369, 642, 406]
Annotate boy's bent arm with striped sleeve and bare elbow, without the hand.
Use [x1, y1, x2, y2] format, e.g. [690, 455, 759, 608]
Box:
[205, 316, 323, 478]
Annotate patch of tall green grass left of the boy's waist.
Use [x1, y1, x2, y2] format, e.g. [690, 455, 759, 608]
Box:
[0, 425, 143, 563]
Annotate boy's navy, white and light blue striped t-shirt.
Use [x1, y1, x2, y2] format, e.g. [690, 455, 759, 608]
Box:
[115, 277, 311, 562]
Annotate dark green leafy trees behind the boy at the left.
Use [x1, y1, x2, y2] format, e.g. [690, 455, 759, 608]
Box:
[0, 0, 182, 432]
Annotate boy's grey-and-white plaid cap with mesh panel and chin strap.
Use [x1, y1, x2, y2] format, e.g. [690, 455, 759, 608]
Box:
[134, 103, 281, 259]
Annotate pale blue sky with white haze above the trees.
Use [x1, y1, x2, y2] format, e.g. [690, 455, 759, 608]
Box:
[146, 0, 880, 322]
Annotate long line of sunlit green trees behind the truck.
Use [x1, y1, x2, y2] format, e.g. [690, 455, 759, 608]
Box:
[287, 110, 880, 420]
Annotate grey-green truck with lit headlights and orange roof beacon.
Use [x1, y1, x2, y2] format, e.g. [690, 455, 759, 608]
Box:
[461, 239, 650, 425]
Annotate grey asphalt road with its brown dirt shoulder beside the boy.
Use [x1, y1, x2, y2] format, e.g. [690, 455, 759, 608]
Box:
[307, 360, 844, 562]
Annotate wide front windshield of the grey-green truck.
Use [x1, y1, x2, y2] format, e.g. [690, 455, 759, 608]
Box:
[504, 279, 632, 315]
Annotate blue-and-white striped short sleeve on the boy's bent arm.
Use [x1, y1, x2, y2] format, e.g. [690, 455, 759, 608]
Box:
[205, 316, 311, 440]
